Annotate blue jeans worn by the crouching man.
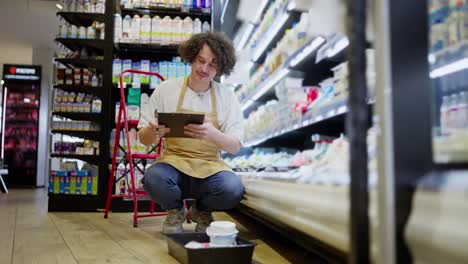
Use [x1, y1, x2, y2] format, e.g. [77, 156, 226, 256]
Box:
[143, 163, 244, 211]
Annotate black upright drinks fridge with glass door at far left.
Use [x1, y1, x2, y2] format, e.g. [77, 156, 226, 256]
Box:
[0, 64, 41, 186]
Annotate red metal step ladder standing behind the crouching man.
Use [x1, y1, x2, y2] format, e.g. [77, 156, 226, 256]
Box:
[104, 70, 190, 227]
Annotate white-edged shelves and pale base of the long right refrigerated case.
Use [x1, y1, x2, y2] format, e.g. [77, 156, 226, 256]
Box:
[220, 1, 362, 263]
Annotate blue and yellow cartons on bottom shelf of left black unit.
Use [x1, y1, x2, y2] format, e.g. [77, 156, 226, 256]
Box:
[49, 170, 98, 195]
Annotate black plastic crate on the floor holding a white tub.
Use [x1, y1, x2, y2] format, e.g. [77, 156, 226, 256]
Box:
[166, 233, 255, 264]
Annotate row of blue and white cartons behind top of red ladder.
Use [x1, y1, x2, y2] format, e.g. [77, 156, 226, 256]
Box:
[112, 57, 192, 89]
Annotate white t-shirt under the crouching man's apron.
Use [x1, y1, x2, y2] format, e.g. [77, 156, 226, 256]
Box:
[138, 78, 244, 144]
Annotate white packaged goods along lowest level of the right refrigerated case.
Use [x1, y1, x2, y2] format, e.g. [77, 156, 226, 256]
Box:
[226, 128, 377, 186]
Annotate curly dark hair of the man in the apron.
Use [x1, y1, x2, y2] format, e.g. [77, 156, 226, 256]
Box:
[179, 32, 236, 76]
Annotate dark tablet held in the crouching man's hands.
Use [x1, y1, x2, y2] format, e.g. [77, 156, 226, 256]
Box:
[158, 113, 205, 138]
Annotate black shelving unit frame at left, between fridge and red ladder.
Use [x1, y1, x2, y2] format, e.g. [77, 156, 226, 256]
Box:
[48, 0, 115, 211]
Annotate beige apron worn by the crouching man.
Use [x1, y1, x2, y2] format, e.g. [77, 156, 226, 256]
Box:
[156, 78, 231, 179]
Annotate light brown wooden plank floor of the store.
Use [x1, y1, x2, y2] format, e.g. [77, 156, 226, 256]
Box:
[0, 189, 322, 264]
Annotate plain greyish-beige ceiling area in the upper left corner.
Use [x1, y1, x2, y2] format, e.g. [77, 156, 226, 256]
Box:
[0, 0, 59, 48]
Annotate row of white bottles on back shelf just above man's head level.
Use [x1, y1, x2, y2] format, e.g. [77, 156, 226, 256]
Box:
[114, 14, 211, 45]
